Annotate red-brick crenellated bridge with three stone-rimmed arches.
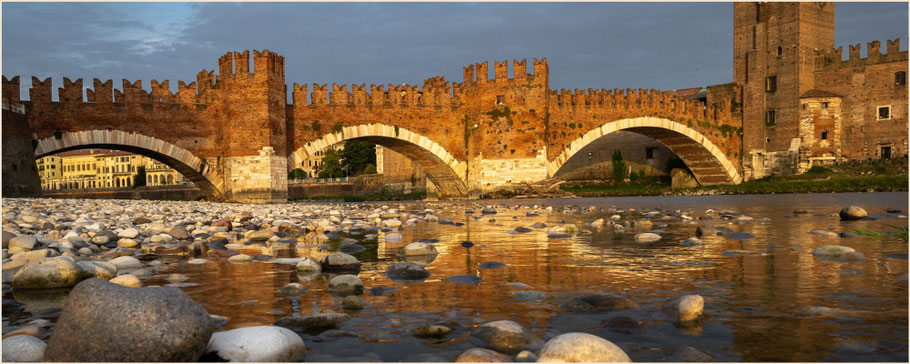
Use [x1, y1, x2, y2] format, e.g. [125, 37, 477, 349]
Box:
[3, 51, 742, 202]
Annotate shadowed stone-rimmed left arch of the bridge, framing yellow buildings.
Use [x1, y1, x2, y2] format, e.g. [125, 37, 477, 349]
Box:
[35, 130, 224, 200]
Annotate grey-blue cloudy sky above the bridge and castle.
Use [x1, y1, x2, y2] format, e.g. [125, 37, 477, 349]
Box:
[0, 1, 908, 100]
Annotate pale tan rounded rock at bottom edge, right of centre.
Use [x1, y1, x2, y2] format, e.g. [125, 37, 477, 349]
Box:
[537, 332, 632, 363]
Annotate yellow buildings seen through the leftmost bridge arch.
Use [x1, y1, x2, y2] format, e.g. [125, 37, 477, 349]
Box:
[37, 149, 186, 190]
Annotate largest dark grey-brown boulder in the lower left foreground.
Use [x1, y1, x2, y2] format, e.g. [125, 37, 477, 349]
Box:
[44, 278, 214, 362]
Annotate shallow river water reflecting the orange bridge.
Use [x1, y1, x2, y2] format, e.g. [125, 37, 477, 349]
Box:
[4, 192, 908, 362]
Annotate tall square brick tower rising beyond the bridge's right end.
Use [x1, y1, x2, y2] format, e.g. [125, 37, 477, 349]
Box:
[733, 2, 834, 156]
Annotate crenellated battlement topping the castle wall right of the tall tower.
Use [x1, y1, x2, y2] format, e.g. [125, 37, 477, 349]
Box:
[815, 38, 907, 71]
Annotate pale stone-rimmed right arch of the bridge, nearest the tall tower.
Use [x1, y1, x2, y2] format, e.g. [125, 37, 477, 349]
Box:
[547, 117, 742, 185]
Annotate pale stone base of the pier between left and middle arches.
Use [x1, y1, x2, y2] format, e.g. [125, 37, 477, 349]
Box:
[222, 147, 288, 203]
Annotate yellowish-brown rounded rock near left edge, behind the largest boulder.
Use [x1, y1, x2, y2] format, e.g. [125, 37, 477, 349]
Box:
[12, 257, 82, 288]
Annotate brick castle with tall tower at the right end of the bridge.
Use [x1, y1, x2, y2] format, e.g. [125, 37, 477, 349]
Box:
[733, 2, 908, 179]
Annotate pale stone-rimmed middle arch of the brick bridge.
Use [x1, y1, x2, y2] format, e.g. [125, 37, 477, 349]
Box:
[288, 124, 468, 197]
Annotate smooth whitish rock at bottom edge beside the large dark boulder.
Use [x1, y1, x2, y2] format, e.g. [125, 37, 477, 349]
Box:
[205, 326, 306, 362]
